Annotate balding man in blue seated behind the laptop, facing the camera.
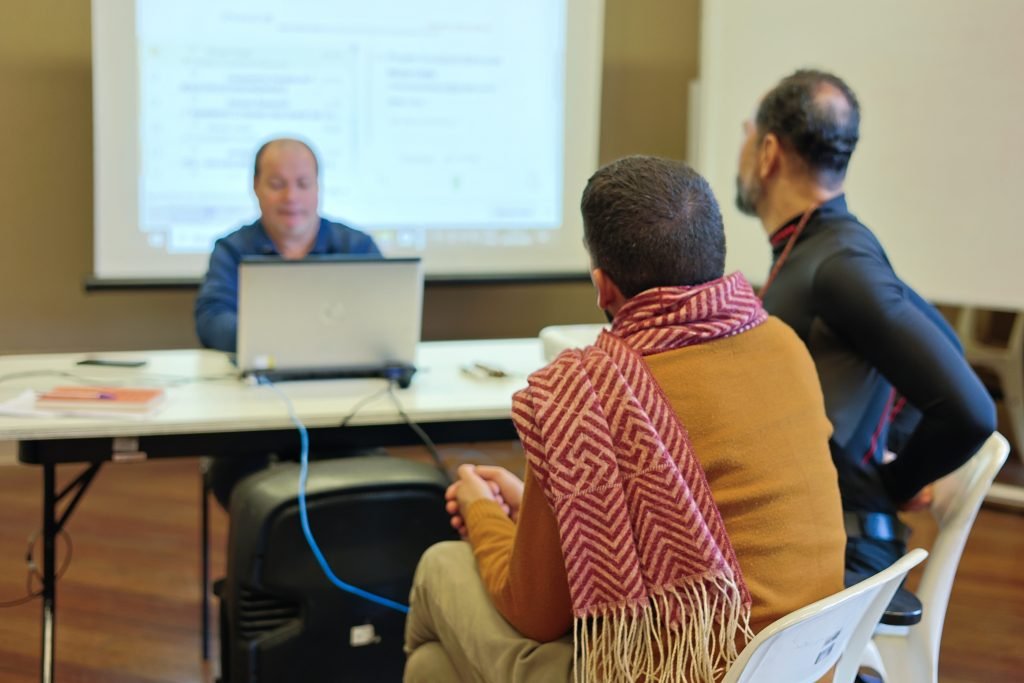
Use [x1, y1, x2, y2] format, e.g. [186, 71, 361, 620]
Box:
[196, 138, 380, 507]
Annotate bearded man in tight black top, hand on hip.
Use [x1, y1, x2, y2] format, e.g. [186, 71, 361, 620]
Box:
[736, 71, 995, 572]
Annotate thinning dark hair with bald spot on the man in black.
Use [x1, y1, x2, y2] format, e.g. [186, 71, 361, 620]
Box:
[756, 69, 860, 186]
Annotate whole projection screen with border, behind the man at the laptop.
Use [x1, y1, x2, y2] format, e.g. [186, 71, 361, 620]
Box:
[92, 0, 604, 280]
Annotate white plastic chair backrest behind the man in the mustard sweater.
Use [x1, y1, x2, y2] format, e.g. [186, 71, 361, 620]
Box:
[723, 548, 928, 683]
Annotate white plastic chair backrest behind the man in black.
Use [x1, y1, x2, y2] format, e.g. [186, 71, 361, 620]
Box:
[907, 432, 1010, 670]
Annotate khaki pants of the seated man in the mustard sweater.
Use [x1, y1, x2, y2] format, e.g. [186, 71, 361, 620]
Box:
[404, 541, 572, 683]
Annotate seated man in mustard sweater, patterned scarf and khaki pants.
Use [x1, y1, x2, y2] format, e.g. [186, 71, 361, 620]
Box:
[406, 157, 844, 683]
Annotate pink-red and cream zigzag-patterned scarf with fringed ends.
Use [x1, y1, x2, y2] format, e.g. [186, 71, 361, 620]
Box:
[512, 273, 768, 682]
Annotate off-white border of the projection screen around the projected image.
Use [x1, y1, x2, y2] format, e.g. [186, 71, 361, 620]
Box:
[91, 0, 604, 280]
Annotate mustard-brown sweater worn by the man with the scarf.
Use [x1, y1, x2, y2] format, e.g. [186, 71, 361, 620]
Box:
[466, 317, 846, 642]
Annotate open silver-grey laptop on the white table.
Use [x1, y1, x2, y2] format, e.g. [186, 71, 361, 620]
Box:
[236, 255, 423, 387]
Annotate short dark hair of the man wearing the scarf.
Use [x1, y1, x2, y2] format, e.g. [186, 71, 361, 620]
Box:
[580, 157, 725, 298]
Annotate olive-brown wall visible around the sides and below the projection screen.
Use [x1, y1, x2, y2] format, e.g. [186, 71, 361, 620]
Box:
[0, 0, 698, 353]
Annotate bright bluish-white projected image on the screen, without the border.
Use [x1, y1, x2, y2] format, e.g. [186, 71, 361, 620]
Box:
[135, 0, 565, 254]
